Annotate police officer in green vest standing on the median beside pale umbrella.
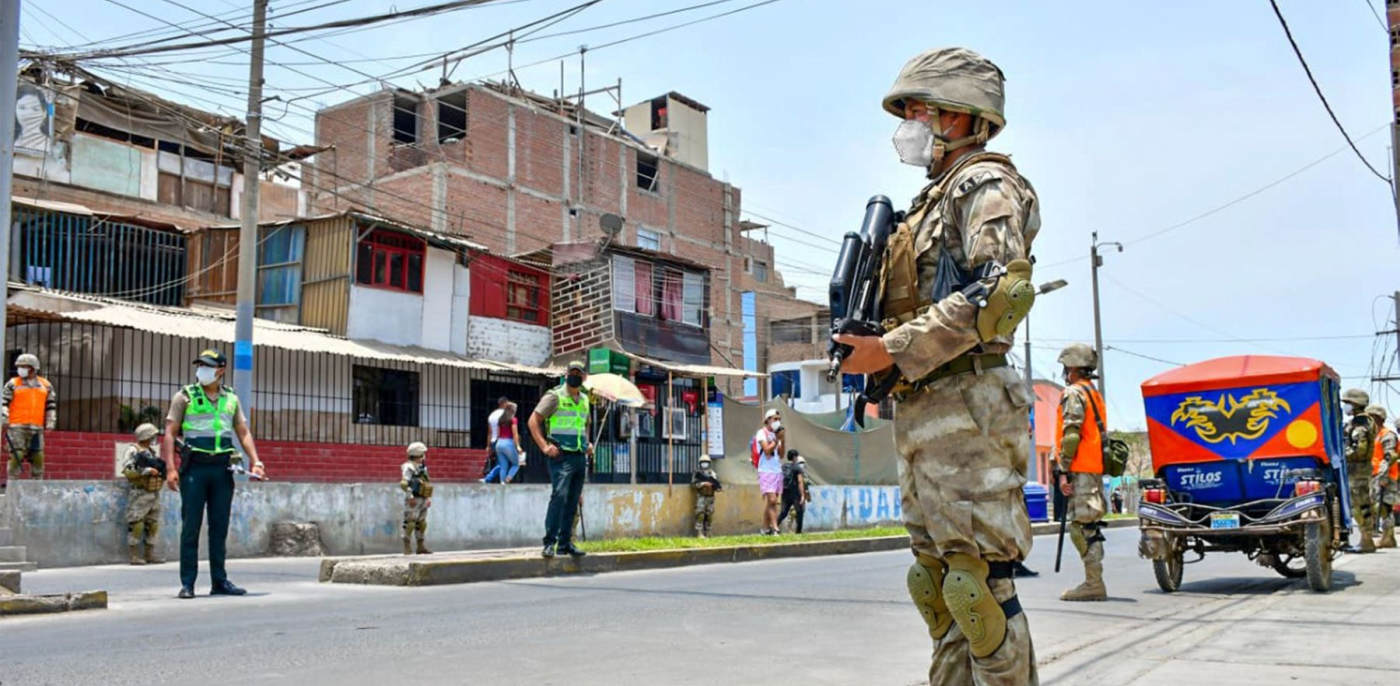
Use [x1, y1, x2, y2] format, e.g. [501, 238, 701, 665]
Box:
[529, 361, 594, 557]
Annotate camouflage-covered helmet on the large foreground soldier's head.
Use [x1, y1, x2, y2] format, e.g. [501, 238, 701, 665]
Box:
[883, 48, 1007, 137]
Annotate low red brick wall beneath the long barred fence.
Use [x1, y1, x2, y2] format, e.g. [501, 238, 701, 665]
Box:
[4, 431, 486, 483]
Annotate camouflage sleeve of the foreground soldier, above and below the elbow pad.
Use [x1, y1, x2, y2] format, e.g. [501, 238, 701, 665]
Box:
[885, 165, 1040, 379]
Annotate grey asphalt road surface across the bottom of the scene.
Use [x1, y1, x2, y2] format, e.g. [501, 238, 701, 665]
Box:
[0, 529, 1400, 686]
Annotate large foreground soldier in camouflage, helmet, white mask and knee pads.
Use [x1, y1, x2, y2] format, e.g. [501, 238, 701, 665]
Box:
[836, 48, 1040, 686]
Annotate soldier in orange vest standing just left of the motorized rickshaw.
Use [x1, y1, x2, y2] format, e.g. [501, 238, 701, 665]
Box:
[1056, 343, 1109, 601]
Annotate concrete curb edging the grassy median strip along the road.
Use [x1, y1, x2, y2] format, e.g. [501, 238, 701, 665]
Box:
[319, 519, 1137, 587]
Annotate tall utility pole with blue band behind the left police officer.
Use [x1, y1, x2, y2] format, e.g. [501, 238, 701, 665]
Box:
[234, 0, 267, 411]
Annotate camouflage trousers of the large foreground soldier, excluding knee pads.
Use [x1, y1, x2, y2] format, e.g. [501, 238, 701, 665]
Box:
[895, 367, 1039, 686]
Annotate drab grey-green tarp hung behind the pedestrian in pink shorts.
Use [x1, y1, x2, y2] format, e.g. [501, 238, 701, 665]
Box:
[715, 398, 899, 486]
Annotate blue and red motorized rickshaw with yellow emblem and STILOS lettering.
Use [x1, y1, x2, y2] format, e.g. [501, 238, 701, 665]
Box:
[1138, 356, 1351, 592]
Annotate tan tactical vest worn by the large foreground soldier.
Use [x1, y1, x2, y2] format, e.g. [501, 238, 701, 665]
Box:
[881, 151, 1015, 330]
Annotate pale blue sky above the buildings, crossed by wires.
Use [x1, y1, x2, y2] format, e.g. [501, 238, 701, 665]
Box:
[21, 0, 1400, 428]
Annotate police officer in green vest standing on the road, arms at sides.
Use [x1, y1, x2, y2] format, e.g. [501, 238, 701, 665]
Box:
[161, 350, 266, 598]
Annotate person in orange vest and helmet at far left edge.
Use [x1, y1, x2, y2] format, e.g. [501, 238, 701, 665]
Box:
[0, 353, 59, 479]
